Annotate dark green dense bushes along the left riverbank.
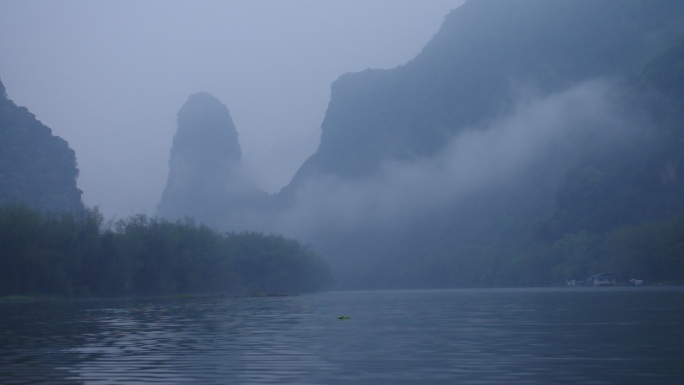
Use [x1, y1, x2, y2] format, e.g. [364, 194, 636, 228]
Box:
[0, 206, 328, 296]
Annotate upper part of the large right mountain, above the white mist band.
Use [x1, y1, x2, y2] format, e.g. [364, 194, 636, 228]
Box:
[284, 0, 684, 193]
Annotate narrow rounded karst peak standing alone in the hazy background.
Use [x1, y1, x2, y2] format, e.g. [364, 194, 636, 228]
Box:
[157, 92, 257, 227]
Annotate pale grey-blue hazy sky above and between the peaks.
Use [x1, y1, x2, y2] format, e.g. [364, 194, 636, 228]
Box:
[0, 0, 462, 217]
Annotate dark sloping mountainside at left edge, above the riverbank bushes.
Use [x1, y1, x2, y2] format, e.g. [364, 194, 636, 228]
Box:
[0, 76, 83, 212]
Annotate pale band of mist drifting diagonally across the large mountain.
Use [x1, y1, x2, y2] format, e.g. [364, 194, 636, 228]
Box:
[271, 81, 628, 239]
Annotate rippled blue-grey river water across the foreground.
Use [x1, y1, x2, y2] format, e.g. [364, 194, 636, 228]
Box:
[0, 287, 684, 385]
